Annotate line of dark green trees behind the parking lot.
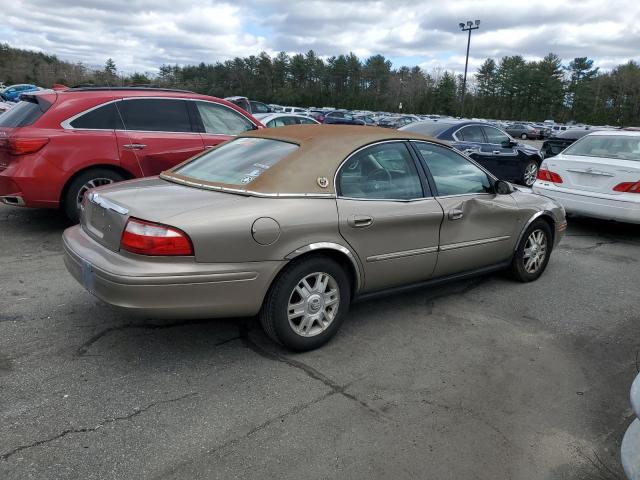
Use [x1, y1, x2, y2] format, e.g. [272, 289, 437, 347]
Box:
[0, 44, 640, 126]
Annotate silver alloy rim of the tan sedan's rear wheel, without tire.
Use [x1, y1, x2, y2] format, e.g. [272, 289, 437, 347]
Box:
[287, 272, 340, 337]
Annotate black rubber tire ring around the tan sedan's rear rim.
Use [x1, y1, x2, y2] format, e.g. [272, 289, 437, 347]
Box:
[269, 257, 351, 351]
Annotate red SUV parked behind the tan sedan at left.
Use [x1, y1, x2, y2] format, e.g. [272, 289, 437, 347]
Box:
[0, 87, 262, 220]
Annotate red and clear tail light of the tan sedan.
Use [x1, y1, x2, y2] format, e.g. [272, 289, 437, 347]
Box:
[120, 218, 193, 256]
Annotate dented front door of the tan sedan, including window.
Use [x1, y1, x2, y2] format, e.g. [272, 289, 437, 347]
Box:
[411, 141, 522, 277]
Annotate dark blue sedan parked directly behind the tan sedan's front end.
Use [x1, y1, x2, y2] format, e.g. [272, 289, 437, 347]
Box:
[400, 120, 542, 187]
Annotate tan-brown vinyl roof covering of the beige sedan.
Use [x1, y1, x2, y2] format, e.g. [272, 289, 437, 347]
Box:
[163, 125, 444, 195]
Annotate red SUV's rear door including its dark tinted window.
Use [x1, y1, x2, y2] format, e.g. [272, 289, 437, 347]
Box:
[116, 98, 204, 177]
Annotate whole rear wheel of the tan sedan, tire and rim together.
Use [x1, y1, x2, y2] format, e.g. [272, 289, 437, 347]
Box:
[258, 256, 351, 351]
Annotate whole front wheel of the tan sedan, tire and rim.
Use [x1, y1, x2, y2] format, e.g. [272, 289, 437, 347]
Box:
[511, 220, 553, 282]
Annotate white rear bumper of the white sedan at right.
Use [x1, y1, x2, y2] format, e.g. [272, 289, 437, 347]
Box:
[533, 181, 640, 223]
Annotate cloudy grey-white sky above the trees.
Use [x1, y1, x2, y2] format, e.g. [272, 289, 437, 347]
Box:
[0, 0, 640, 73]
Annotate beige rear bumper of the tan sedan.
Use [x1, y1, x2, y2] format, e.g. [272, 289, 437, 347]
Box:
[63, 226, 286, 319]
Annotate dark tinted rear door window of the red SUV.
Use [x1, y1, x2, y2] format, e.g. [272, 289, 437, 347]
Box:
[118, 98, 193, 132]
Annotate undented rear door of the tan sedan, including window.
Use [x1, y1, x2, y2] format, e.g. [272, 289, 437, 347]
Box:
[336, 141, 443, 291]
